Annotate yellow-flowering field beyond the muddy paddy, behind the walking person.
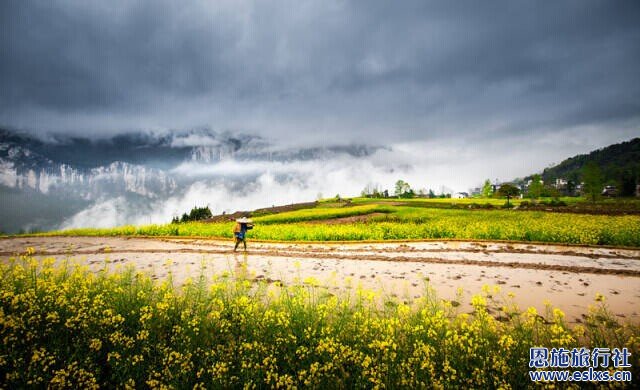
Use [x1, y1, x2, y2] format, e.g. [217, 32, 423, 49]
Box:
[31, 199, 640, 247]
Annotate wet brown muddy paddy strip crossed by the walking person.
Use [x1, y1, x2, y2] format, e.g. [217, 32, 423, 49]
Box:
[0, 237, 640, 323]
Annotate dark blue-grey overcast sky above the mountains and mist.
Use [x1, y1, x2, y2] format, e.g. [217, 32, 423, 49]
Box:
[0, 0, 640, 183]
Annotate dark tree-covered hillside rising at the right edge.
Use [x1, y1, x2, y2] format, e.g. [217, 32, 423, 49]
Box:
[525, 138, 640, 195]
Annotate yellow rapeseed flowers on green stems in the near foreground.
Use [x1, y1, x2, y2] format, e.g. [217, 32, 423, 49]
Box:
[0, 253, 640, 388]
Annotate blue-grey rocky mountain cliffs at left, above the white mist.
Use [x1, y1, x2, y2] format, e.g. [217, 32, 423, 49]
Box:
[0, 129, 379, 232]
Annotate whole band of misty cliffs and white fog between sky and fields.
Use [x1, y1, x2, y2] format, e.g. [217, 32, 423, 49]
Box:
[0, 128, 636, 233]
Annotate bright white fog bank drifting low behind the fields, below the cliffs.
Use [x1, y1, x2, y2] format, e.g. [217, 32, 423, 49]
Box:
[57, 123, 631, 228]
